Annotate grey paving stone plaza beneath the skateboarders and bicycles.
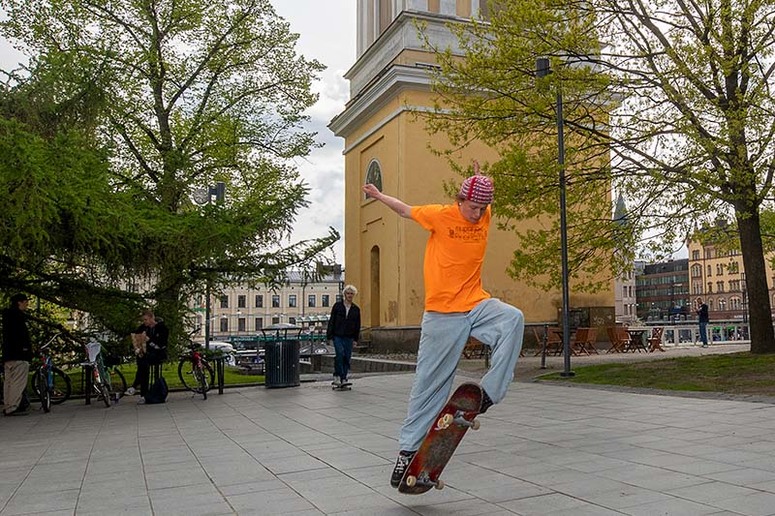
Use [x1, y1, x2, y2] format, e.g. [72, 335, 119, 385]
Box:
[0, 356, 775, 516]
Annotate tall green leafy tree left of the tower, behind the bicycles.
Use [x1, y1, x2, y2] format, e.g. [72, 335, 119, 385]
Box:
[2, 0, 338, 346]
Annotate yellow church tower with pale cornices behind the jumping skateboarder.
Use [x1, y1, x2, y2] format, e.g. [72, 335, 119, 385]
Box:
[329, 0, 614, 343]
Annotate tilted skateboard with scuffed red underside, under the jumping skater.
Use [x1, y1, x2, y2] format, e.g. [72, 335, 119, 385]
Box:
[398, 382, 482, 494]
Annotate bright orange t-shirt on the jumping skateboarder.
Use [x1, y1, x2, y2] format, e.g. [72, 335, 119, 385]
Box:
[411, 204, 491, 313]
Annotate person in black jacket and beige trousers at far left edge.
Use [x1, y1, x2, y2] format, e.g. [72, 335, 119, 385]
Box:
[3, 294, 32, 416]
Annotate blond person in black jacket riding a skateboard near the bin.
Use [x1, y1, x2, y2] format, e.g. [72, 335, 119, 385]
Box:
[326, 285, 361, 387]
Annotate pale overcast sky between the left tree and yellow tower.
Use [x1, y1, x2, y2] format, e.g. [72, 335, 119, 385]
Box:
[0, 0, 356, 263]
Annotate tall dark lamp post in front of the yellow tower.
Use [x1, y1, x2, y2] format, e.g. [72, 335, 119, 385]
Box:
[536, 57, 575, 378]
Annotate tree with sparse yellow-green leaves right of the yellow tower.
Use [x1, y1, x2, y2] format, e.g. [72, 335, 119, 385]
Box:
[422, 0, 775, 353]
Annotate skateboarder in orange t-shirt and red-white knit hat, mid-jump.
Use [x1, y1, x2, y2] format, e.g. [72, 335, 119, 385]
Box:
[363, 162, 525, 487]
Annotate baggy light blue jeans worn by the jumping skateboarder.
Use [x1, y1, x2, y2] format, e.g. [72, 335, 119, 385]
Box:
[398, 298, 525, 451]
